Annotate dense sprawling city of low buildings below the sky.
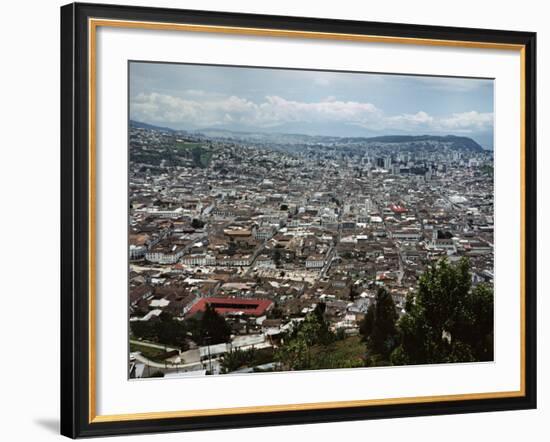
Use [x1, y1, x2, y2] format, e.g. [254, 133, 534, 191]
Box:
[129, 121, 493, 378]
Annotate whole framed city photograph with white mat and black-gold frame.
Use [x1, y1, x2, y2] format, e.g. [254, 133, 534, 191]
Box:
[61, 4, 536, 438]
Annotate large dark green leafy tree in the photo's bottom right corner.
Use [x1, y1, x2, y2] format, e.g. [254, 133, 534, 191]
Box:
[391, 258, 493, 365]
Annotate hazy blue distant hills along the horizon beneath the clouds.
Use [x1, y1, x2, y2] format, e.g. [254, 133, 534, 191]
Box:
[130, 120, 484, 152]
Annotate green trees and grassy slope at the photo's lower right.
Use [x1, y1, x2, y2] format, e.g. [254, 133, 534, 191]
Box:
[275, 258, 493, 370]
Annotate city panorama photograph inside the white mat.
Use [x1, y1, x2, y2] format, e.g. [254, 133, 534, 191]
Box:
[127, 60, 496, 379]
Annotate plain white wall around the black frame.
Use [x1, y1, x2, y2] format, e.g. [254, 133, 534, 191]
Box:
[0, 0, 550, 442]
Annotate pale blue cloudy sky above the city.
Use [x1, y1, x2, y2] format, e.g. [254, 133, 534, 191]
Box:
[129, 62, 494, 148]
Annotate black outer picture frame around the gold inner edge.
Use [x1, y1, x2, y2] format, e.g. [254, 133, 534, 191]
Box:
[61, 3, 537, 438]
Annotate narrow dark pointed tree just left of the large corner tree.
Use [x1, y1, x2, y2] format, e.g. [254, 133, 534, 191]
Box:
[359, 287, 398, 365]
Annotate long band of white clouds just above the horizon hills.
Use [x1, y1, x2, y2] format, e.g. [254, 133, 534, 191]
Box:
[130, 90, 493, 134]
